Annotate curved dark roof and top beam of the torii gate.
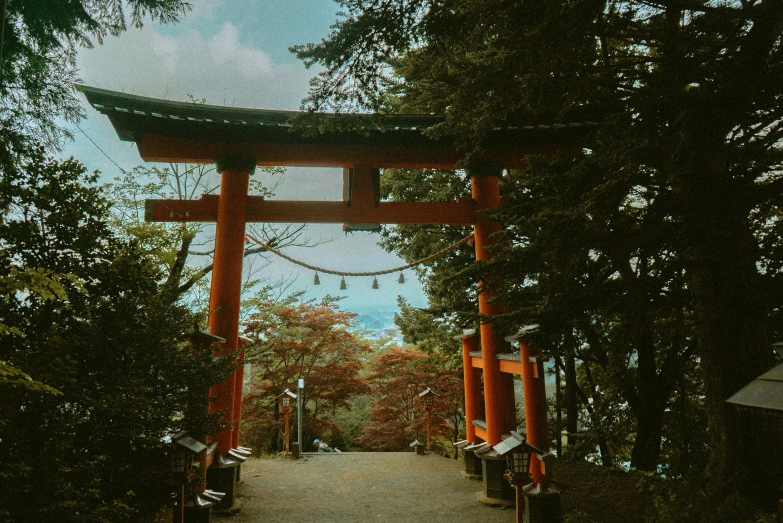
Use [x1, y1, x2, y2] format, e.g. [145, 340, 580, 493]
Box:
[77, 85, 598, 169]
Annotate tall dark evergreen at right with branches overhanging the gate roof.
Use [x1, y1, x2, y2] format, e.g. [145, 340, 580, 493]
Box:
[294, 0, 783, 502]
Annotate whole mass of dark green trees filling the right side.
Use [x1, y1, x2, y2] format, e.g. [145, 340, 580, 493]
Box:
[302, 0, 783, 503]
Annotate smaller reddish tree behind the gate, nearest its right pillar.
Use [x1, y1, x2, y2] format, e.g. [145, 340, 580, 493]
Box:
[359, 348, 463, 453]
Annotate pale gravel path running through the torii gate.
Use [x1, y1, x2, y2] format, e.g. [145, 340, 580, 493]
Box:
[222, 452, 514, 523]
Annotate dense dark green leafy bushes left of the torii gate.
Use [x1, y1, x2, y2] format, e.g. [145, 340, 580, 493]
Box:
[0, 151, 230, 522]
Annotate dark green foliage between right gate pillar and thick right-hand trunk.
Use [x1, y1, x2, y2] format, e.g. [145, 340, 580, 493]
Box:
[494, 153, 698, 470]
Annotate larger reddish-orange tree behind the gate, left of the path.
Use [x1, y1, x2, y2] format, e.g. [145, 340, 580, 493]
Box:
[243, 291, 370, 452]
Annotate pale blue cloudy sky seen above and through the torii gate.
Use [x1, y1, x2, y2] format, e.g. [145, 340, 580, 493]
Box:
[63, 0, 426, 316]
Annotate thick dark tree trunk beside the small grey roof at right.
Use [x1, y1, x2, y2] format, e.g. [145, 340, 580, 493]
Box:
[684, 172, 783, 505]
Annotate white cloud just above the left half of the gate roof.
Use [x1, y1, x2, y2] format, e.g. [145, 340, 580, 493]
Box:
[77, 22, 314, 109]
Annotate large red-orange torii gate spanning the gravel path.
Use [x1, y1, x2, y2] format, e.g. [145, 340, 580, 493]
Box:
[79, 86, 596, 506]
